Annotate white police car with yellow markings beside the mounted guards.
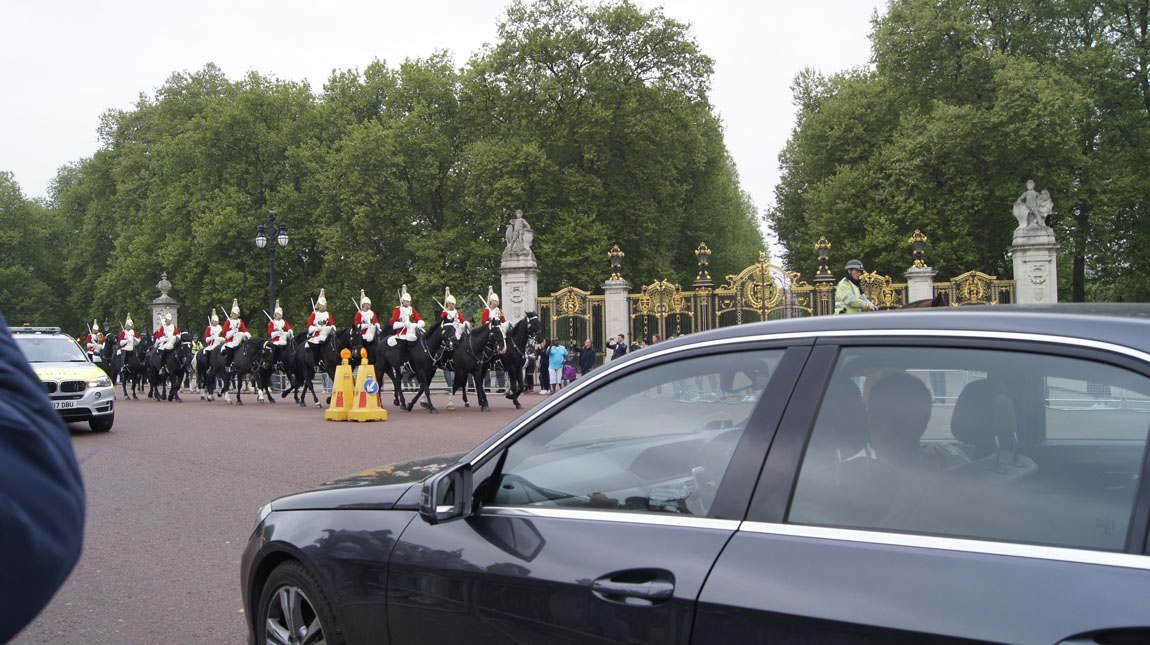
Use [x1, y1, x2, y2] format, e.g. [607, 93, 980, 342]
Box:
[10, 327, 116, 432]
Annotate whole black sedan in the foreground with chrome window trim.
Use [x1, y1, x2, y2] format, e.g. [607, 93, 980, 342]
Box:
[242, 306, 1150, 645]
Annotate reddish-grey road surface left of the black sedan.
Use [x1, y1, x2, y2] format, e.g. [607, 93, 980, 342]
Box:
[13, 389, 546, 645]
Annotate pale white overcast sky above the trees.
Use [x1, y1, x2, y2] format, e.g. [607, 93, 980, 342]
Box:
[0, 0, 886, 252]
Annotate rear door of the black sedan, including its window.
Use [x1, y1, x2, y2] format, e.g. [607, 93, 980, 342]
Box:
[693, 333, 1150, 643]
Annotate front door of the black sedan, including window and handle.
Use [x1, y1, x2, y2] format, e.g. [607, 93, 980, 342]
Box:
[388, 346, 808, 645]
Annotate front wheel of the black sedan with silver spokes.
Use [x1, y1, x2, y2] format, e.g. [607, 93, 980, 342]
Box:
[262, 561, 344, 645]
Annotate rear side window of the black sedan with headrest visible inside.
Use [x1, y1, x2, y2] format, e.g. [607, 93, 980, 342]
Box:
[788, 347, 1150, 550]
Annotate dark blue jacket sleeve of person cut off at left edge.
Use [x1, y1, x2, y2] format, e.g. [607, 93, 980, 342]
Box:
[0, 315, 84, 643]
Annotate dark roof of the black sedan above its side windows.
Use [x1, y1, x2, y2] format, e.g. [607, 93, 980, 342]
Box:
[636, 304, 1150, 354]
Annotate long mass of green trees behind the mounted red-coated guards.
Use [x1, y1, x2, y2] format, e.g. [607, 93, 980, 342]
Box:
[0, 0, 764, 329]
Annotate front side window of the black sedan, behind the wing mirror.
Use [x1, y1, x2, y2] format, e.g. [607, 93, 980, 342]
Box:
[491, 350, 783, 515]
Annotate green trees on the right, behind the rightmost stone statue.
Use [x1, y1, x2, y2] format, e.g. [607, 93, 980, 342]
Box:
[768, 0, 1150, 300]
